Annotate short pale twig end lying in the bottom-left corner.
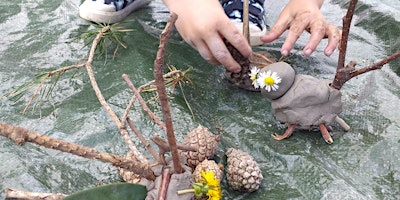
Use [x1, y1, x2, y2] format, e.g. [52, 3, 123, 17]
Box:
[6, 188, 68, 200]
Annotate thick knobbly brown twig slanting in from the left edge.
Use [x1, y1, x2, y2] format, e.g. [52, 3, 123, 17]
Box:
[0, 122, 155, 180]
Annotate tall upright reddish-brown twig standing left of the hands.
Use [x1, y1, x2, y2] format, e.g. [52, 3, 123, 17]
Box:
[154, 13, 183, 174]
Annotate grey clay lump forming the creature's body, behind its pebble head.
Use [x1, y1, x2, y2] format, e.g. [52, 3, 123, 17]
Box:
[271, 75, 342, 129]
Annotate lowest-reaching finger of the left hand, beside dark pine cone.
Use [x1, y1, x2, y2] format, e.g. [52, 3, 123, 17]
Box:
[207, 36, 241, 73]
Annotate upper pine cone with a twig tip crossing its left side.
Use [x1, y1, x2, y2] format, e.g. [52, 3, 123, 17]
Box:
[180, 125, 219, 169]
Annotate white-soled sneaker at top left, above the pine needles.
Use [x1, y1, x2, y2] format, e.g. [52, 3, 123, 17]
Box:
[79, 0, 151, 24]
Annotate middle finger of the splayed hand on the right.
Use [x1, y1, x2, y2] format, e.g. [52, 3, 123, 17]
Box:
[303, 19, 327, 56]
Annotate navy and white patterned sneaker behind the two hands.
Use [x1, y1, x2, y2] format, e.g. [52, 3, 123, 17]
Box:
[222, 0, 267, 46]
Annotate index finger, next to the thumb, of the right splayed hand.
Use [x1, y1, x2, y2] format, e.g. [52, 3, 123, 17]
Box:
[281, 18, 308, 56]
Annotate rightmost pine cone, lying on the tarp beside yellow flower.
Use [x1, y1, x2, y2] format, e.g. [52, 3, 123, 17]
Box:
[226, 148, 263, 192]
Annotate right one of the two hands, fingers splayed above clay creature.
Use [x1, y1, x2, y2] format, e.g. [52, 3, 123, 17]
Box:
[261, 0, 341, 56]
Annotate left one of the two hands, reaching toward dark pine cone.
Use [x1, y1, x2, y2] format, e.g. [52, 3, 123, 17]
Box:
[164, 0, 252, 72]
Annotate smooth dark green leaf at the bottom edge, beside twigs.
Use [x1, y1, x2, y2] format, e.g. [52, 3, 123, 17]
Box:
[64, 183, 147, 200]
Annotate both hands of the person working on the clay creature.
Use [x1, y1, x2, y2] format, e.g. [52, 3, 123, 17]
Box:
[164, 0, 341, 72]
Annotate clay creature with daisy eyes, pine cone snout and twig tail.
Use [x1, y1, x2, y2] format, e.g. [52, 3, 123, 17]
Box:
[226, 0, 400, 144]
